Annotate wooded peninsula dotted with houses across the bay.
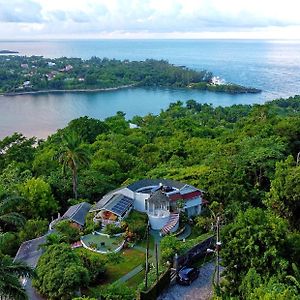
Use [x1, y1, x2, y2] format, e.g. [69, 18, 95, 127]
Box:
[0, 55, 261, 95]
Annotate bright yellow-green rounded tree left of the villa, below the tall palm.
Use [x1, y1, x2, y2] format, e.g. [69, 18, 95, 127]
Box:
[19, 177, 58, 219]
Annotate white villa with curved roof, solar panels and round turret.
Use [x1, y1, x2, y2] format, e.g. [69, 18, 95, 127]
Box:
[90, 179, 203, 235]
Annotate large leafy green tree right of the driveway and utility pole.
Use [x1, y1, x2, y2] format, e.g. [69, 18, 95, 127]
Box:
[222, 208, 288, 294]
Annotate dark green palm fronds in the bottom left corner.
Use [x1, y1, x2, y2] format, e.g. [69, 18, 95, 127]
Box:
[0, 255, 34, 300]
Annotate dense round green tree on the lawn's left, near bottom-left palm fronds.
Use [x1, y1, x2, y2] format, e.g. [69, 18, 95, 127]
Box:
[33, 243, 90, 299]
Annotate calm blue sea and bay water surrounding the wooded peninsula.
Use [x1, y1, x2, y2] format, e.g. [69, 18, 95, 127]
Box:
[0, 40, 300, 138]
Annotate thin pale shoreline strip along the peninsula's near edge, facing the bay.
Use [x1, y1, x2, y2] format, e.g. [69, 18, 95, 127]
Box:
[0, 84, 136, 96]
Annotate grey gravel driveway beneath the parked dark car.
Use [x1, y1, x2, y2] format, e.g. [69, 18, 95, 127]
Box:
[158, 262, 215, 300]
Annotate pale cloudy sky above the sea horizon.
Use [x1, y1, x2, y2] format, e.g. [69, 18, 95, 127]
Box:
[0, 0, 300, 40]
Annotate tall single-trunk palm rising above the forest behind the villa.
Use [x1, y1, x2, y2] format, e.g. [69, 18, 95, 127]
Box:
[59, 132, 90, 199]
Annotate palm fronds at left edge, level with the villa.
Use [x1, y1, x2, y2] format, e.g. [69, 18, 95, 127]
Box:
[0, 194, 25, 232]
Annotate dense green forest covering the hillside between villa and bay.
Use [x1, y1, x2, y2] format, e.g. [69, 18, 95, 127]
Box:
[0, 95, 300, 299]
